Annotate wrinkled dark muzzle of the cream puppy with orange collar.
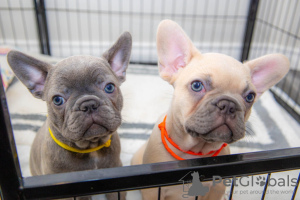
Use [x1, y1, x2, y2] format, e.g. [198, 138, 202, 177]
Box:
[185, 95, 245, 143]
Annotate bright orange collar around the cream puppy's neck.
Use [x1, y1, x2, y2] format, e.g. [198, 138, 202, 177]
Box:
[158, 116, 227, 160]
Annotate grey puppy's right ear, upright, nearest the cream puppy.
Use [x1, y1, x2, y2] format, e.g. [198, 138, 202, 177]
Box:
[102, 32, 132, 83]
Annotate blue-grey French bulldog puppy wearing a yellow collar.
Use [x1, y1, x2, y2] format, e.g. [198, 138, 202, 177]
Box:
[8, 32, 132, 199]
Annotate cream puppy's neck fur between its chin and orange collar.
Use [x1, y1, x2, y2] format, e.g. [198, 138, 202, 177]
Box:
[166, 110, 223, 154]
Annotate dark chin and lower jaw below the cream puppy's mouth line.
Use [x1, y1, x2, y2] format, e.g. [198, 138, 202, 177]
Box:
[186, 123, 237, 144]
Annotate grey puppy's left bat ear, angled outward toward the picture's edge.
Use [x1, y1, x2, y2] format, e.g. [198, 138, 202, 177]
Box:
[7, 51, 52, 99]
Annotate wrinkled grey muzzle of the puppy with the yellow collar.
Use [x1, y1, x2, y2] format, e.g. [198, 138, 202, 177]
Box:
[64, 95, 120, 141]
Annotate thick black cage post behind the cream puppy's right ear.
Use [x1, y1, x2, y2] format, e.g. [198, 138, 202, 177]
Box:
[240, 0, 259, 62]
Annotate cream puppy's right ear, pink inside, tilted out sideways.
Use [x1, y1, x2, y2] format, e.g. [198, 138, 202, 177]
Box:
[245, 54, 290, 97]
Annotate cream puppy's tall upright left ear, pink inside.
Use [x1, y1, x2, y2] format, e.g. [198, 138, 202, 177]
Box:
[156, 20, 196, 84]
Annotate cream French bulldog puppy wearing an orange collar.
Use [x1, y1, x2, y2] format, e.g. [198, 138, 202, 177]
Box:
[132, 20, 289, 200]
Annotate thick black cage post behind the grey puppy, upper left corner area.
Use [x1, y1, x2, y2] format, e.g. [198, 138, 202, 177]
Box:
[33, 0, 51, 55]
